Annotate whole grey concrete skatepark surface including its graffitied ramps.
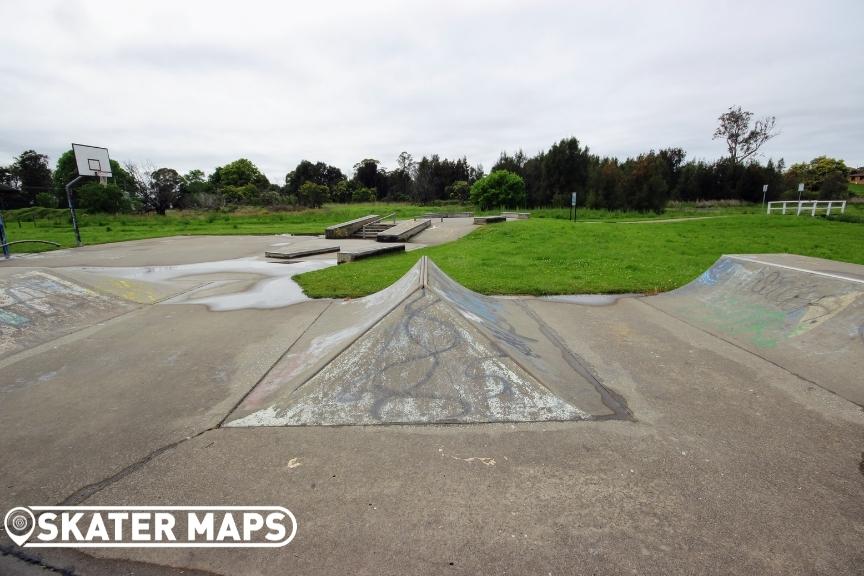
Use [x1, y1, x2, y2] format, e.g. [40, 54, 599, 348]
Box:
[0, 224, 864, 574]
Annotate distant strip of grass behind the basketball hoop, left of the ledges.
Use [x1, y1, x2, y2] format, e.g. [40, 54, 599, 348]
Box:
[3, 203, 470, 252]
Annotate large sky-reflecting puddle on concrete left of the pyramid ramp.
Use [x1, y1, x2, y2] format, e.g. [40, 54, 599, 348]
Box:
[76, 258, 336, 312]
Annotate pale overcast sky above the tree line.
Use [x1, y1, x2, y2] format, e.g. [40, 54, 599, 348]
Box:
[0, 0, 864, 184]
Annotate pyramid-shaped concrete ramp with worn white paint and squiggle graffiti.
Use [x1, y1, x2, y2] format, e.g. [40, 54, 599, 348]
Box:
[225, 257, 629, 426]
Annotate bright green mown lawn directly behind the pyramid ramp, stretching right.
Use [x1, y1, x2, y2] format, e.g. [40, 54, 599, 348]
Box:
[296, 215, 864, 297]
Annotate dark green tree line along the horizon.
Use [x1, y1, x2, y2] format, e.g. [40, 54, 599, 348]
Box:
[0, 107, 860, 214]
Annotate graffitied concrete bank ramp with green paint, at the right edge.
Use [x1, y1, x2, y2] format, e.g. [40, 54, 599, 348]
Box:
[643, 254, 864, 405]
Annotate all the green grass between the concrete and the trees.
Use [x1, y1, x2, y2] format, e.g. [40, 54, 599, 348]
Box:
[4, 204, 864, 297]
